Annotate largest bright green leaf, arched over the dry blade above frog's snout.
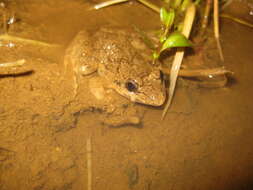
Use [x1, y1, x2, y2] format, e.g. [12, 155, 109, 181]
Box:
[160, 32, 192, 52]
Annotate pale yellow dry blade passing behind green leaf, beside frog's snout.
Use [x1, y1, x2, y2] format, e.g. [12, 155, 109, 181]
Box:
[162, 3, 196, 119]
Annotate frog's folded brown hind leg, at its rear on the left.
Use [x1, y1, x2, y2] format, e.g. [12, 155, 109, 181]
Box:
[64, 31, 98, 96]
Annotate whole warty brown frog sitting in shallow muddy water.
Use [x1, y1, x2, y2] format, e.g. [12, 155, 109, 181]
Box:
[64, 26, 166, 127]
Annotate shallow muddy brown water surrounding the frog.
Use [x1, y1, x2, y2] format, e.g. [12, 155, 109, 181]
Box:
[0, 0, 253, 190]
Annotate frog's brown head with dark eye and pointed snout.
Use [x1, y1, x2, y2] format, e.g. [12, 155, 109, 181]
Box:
[112, 69, 166, 106]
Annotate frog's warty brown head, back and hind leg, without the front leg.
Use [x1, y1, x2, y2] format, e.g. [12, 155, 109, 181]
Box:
[64, 27, 166, 106]
